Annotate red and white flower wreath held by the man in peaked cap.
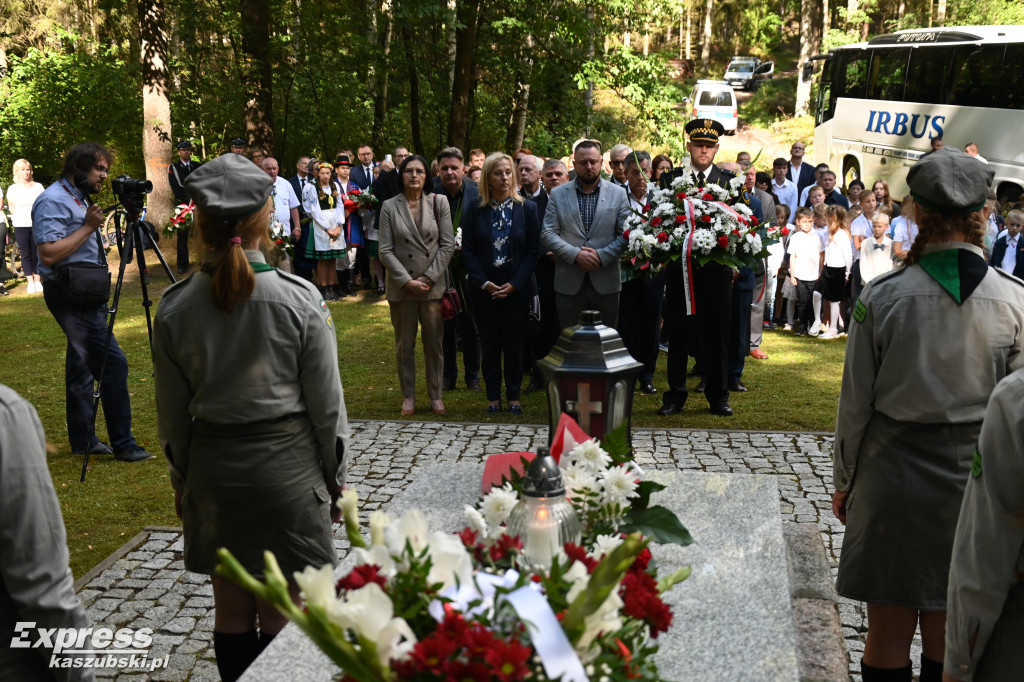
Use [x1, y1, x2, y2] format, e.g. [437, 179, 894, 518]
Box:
[623, 173, 779, 274]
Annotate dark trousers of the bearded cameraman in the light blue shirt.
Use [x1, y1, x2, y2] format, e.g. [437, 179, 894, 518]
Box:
[43, 282, 135, 453]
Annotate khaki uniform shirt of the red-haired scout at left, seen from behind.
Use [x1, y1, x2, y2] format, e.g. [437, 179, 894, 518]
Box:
[153, 251, 348, 489]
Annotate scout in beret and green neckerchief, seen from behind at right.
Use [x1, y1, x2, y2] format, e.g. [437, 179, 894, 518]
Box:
[833, 135, 1024, 682]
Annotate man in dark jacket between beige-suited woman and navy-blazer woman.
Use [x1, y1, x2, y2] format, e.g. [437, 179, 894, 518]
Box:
[434, 146, 480, 391]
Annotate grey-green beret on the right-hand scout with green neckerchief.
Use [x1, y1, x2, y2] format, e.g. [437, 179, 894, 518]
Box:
[906, 146, 995, 213]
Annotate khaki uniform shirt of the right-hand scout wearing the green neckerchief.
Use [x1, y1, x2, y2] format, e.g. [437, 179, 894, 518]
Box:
[834, 242, 1024, 491]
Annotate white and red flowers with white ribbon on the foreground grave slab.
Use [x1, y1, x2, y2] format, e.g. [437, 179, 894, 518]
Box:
[217, 417, 692, 682]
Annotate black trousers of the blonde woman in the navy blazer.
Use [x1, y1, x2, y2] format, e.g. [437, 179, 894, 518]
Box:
[472, 289, 529, 401]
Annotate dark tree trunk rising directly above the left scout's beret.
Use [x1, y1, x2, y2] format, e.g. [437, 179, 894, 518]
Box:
[239, 0, 273, 154]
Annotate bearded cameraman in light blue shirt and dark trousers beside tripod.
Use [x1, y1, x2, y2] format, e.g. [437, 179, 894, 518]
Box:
[32, 142, 153, 462]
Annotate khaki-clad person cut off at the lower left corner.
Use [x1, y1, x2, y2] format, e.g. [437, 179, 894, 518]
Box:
[0, 385, 95, 682]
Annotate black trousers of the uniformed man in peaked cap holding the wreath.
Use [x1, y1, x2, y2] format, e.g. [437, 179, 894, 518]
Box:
[664, 262, 732, 406]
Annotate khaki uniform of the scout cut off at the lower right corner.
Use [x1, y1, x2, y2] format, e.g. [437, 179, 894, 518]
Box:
[945, 372, 1024, 682]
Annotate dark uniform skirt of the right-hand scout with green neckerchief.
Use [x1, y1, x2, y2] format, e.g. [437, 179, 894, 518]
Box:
[836, 413, 981, 610]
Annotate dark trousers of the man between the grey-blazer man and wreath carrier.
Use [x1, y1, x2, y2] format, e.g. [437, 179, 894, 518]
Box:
[618, 271, 665, 383]
